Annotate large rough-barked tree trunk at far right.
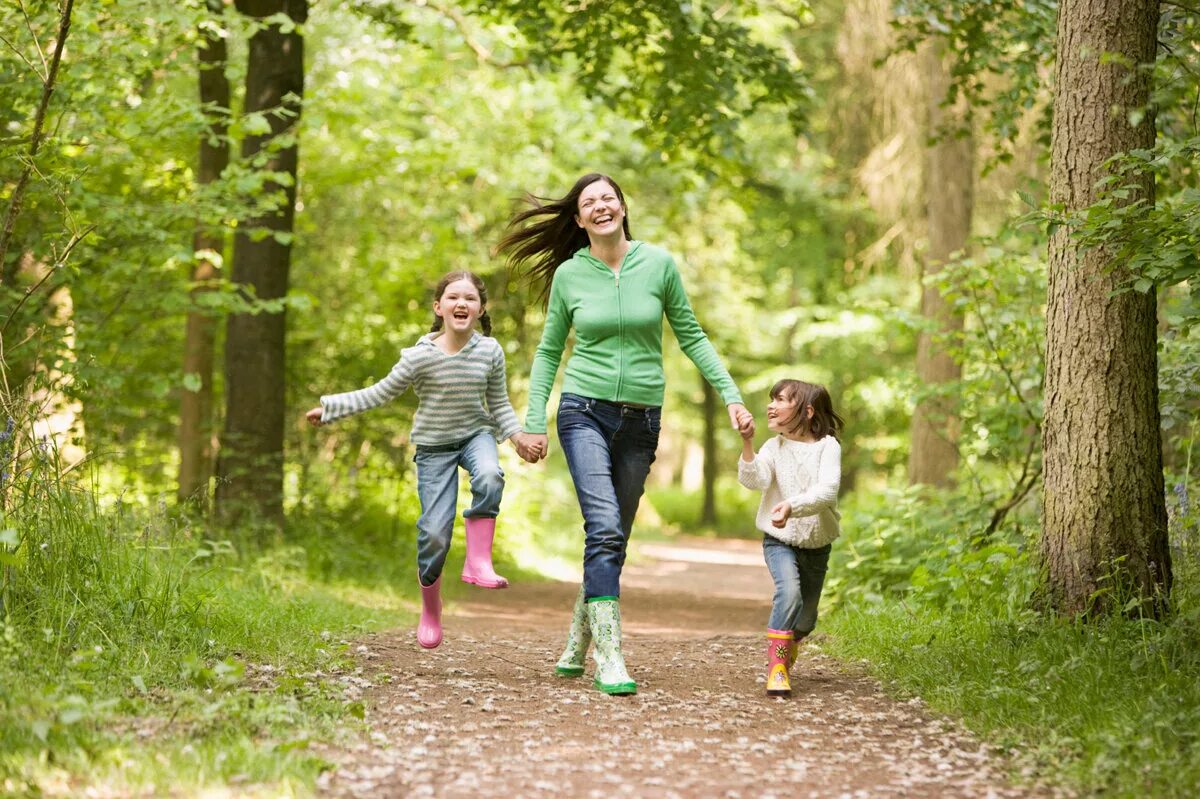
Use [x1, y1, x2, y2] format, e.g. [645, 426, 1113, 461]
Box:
[1042, 0, 1171, 613]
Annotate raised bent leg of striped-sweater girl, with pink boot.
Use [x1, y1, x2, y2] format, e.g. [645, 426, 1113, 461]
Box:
[460, 431, 509, 588]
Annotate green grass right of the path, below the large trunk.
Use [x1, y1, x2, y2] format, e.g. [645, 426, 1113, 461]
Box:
[822, 601, 1200, 798]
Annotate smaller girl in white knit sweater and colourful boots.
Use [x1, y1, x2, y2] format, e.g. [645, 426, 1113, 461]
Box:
[738, 380, 844, 696]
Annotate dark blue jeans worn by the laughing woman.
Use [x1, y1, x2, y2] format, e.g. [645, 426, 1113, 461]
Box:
[558, 394, 662, 599]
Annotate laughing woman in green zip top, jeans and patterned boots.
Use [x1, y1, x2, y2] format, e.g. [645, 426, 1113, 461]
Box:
[499, 174, 754, 695]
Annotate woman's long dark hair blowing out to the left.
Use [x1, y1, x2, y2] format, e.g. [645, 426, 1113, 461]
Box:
[496, 172, 634, 302]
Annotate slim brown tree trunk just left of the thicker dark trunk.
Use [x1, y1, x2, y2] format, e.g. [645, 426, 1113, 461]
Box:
[179, 0, 229, 509]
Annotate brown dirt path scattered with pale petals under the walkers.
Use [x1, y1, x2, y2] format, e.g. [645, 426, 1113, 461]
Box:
[322, 541, 1037, 799]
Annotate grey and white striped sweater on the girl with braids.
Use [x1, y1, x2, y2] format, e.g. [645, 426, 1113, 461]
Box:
[320, 332, 521, 446]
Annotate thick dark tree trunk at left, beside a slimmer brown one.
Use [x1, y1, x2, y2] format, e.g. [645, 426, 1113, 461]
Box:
[216, 0, 308, 527]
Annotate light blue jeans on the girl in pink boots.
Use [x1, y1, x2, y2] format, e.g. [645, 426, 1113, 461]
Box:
[413, 431, 504, 585]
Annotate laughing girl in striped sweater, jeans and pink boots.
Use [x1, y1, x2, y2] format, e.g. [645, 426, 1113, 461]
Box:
[305, 272, 540, 649]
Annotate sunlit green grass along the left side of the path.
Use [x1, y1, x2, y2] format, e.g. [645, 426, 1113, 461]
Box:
[0, 470, 415, 797]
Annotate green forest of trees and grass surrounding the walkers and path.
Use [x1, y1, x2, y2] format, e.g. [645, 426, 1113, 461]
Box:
[0, 0, 1200, 795]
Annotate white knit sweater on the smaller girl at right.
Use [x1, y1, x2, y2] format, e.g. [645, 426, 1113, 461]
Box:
[738, 435, 841, 549]
